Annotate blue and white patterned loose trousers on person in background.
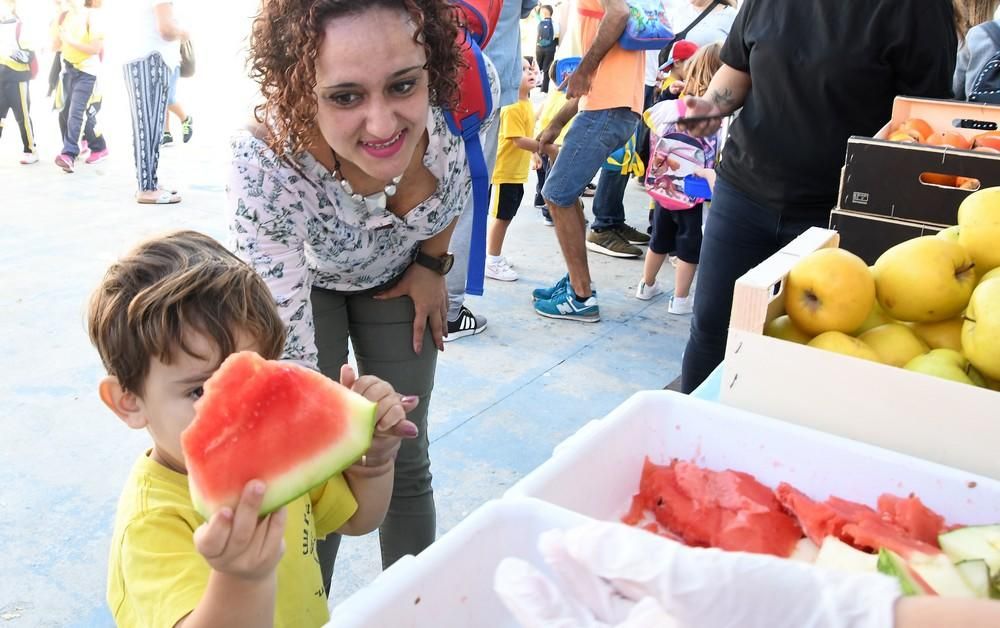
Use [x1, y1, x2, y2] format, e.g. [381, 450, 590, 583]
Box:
[124, 52, 170, 192]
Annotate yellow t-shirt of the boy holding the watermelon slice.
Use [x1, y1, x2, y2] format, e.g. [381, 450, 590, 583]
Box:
[107, 452, 357, 628]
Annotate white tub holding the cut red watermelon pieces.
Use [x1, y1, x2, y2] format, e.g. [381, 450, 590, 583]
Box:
[506, 390, 1000, 524]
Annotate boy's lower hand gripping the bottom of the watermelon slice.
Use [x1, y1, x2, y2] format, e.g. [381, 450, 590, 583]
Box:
[194, 480, 287, 580]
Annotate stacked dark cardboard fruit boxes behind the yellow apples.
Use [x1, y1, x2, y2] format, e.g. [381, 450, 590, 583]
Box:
[830, 97, 1000, 264]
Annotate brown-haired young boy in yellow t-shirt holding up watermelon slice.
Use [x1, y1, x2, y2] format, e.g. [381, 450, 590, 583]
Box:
[88, 231, 416, 628]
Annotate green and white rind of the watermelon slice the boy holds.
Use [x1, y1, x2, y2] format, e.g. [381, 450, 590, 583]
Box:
[189, 393, 378, 520]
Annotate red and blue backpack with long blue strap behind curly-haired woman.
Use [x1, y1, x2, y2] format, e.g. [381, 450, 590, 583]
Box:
[444, 0, 503, 296]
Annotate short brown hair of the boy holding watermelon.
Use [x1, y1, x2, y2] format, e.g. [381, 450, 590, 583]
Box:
[87, 231, 285, 395]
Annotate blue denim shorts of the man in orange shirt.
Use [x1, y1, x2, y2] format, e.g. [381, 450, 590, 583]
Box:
[542, 107, 639, 207]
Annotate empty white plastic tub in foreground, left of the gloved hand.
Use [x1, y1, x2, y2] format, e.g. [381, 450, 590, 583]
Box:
[329, 499, 589, 628]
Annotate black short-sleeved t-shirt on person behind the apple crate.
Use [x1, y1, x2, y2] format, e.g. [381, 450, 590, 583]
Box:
[719, 0, 958, 216]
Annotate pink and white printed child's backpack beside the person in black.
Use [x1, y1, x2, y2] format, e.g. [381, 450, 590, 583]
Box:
[643, 100, 718, 210]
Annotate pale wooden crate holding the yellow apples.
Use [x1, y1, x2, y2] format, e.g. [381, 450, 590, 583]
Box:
[720, 227, 1000, 482]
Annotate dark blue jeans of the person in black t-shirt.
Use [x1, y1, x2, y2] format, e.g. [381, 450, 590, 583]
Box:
[681, 177, 829, 393]
